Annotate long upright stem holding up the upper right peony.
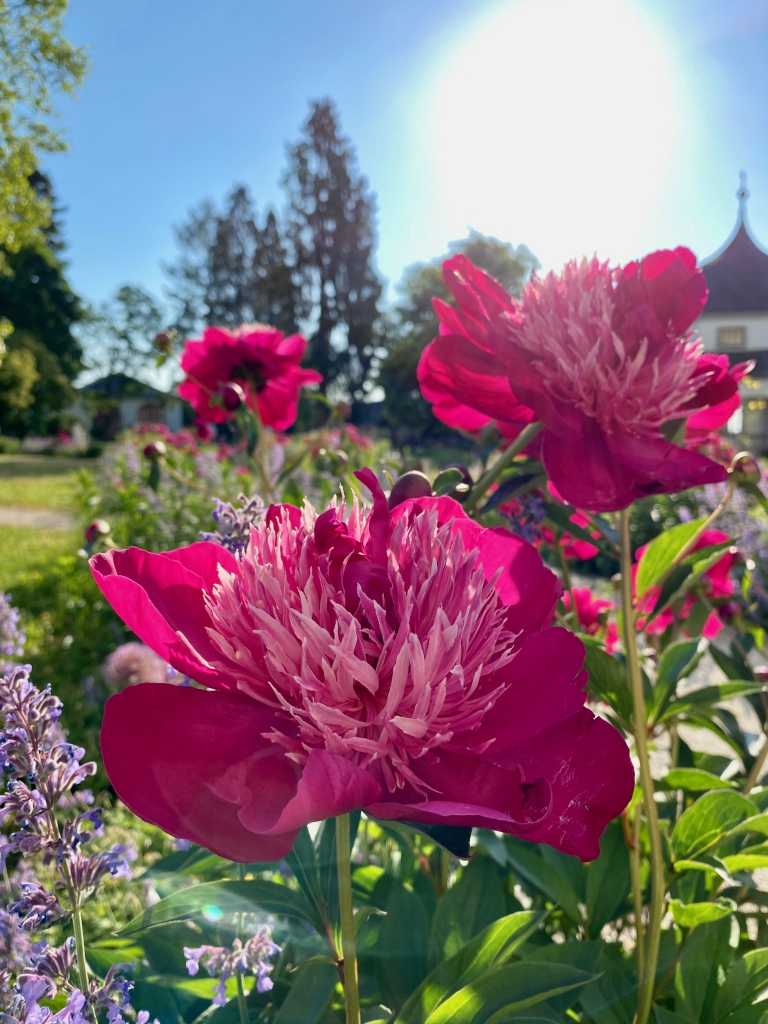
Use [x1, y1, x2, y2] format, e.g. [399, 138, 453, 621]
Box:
[622, 509, 665, 1024]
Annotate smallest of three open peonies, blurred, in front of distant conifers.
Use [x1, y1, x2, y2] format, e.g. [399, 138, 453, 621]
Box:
[178, 324, 323, 430]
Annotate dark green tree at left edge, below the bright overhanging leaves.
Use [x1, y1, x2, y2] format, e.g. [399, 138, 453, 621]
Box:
[0, 172, 83, 435]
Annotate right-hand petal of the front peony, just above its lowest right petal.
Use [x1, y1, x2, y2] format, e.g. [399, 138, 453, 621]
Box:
[456, 626, 587, 752]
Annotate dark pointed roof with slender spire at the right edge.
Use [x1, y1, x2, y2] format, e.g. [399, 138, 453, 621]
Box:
[701, 171, 768, 316]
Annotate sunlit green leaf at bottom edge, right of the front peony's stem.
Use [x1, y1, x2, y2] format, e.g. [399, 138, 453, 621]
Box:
[425, 961, 596, 1024]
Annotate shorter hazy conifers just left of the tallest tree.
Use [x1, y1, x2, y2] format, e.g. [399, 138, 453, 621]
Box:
[166, 185, 300, 336]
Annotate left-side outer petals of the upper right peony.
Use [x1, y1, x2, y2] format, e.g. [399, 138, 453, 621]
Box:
[417, 255, 535, 437]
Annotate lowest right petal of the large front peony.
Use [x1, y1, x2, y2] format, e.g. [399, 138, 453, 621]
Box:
[488, 708, 635, 861]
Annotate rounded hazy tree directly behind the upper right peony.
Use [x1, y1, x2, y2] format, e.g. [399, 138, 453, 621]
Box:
[377, 230, 539, 440]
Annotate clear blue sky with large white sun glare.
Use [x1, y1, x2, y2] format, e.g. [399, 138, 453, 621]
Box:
[46, 0, 768, 315]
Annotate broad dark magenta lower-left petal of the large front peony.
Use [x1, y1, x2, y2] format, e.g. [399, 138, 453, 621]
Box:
[101, 683, 300, 862]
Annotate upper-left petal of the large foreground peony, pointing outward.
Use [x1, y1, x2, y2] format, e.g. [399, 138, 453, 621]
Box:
[90, 543, 237, 689]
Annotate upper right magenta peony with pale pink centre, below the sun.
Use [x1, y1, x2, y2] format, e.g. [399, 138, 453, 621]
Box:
[419, 248, 750, 511]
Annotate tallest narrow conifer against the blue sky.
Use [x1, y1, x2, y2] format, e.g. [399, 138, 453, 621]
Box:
[285, 99, 382, 401]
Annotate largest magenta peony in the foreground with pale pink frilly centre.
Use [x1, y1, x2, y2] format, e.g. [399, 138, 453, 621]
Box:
[91, 470, 634, 861]
